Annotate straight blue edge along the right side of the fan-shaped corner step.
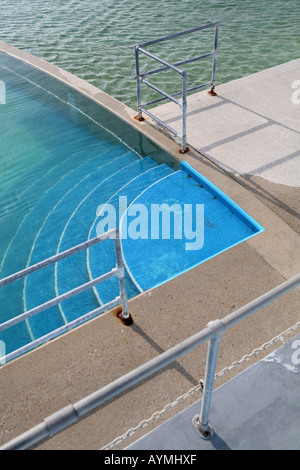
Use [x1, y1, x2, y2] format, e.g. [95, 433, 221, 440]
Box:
[180, 161, 265, 234]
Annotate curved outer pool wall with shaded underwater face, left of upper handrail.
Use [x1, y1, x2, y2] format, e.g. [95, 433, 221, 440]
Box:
[0, 42, 179, 169]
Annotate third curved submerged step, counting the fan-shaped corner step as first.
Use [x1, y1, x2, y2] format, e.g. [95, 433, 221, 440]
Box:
[55, 157, 161, 322]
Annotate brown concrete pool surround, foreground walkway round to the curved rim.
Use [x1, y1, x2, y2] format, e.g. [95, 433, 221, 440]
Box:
[0, 43, 300, 449]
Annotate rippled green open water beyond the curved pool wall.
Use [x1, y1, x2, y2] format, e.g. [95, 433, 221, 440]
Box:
[0, 0, 300, 107]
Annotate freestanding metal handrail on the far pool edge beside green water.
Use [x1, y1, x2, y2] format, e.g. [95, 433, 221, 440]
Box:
[134, 21, 219, 153]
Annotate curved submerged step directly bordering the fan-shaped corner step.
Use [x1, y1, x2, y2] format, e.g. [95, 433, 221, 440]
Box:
[87, 164, 174, 303]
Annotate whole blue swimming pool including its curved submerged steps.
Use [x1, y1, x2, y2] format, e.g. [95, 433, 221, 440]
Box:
[0, 53, 263, 360]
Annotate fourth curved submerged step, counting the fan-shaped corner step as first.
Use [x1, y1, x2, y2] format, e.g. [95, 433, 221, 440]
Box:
[24, 152, 137, 338]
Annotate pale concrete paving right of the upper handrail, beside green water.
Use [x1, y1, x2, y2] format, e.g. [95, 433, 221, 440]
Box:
[152, 59, 300, 187]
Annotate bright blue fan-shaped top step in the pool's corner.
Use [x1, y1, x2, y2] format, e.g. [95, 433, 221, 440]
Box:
[121, 162, 263, 292]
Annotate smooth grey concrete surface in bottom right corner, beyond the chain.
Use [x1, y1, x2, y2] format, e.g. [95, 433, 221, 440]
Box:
[127, 335, 300, 450]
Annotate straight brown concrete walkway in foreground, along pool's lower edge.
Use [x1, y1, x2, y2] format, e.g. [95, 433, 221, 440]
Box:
[0, 244, 300, 449]
